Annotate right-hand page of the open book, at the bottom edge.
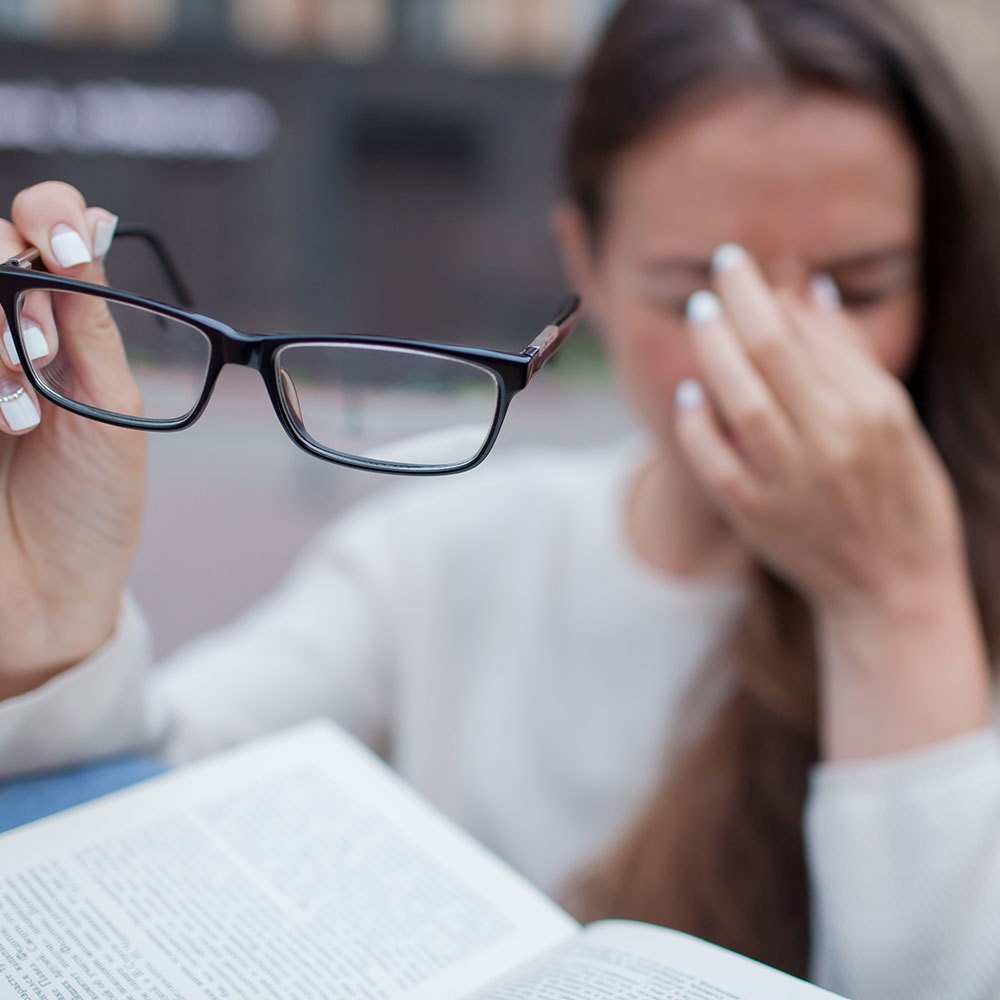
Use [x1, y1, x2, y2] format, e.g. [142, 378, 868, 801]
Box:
[470, 920, 834, 1000]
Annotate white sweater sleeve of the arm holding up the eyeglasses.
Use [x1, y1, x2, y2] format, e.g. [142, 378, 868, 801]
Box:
[0, 488, 406, 778]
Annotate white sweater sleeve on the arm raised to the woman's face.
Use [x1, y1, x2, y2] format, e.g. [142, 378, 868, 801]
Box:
[805, 728, 1000, 1000]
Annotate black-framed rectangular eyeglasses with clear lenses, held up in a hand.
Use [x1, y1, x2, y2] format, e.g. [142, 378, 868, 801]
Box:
[0, 226, 580, 475]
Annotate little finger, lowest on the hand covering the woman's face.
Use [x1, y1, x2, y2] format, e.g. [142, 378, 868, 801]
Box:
[674, 379, 756, 510]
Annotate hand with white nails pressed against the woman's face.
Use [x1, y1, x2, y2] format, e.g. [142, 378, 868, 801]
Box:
[676, 245, 965, 607]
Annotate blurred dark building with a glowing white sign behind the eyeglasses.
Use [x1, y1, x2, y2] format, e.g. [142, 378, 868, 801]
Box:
[0, 0, 609, 343]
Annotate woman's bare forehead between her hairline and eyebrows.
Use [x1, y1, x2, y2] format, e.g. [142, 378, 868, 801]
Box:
[607, 91, 920, 256]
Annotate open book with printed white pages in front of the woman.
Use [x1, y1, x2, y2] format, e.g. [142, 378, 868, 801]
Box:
[0, 723, 844, 1000]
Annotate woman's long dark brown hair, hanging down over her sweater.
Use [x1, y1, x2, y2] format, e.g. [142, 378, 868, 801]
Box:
[564, 0, 1000, 975]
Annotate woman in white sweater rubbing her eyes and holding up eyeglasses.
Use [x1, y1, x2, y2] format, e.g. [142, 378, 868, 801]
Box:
[0, 0, 1000, 1000]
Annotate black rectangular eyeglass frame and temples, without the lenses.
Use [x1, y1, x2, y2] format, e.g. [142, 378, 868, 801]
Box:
[0, 225, 580, 476]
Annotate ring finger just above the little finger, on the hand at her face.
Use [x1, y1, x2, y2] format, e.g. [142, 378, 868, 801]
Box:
[687, 292, 792, 472]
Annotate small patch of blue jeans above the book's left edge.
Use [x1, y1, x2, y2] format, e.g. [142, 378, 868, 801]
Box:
[0, 757, 166, 833]
